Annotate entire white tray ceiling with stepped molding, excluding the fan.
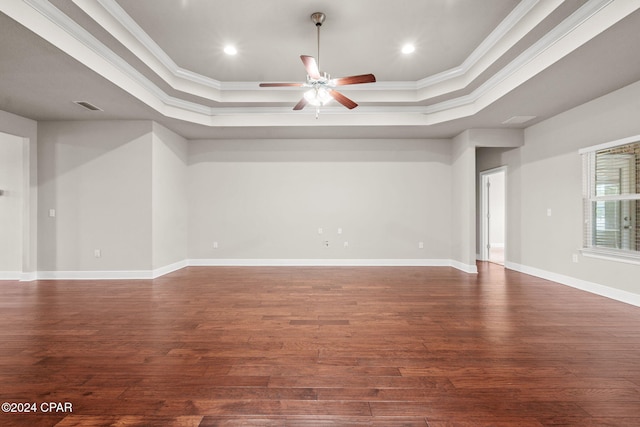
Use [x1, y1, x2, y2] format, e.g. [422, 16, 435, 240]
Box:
[0, 0, 640, 139]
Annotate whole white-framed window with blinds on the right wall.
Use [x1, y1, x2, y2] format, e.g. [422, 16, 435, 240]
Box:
[580, 135, 640, 262]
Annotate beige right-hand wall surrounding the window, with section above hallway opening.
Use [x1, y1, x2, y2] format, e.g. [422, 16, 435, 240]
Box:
[478, 78, 640, 301]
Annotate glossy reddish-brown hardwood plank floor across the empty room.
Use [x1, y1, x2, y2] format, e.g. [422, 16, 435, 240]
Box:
[0, 263, 640, 427]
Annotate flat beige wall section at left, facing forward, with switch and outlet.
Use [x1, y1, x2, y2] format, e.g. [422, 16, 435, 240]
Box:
[38, 121, 152, 272]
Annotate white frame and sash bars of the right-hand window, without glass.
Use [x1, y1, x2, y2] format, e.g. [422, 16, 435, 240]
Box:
[579, 135, 640, 264]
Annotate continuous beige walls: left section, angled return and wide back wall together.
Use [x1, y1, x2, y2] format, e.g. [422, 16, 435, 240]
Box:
[31, 122, 460, 277]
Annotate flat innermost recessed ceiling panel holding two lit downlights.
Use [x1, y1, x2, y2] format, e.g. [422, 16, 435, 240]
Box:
[112, 0, 518, 82]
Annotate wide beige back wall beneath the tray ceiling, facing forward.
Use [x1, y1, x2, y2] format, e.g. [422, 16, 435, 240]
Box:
[189, 140, 451, 260]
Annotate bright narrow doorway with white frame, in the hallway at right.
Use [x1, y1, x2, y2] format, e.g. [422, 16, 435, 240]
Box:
[480, 166, 507, 265]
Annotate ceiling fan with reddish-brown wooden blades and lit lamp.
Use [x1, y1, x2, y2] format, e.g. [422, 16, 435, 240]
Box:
[260, 12, 376, 113]
